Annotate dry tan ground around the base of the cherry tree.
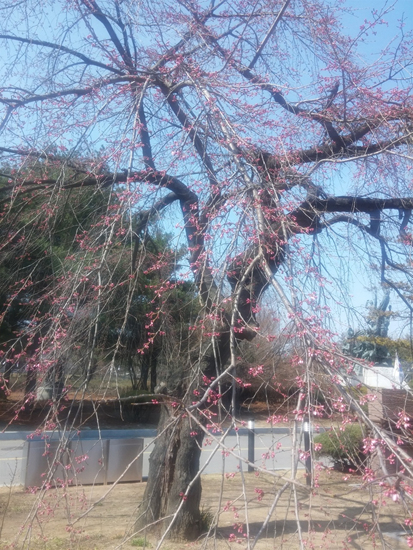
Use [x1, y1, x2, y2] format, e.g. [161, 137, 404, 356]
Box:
[0, 470, 409, 550]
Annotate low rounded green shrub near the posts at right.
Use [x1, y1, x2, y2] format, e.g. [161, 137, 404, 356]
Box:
[314, 424, 366, 470]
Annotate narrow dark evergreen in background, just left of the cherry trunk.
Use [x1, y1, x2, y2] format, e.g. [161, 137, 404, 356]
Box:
[103, 230, 197, 392]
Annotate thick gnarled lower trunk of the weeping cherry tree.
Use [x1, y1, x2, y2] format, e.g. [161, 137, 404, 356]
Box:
[136, 330, 230, 540]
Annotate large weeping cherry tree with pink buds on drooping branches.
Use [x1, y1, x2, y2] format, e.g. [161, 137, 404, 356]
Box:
[0, 0, 413, 537]
